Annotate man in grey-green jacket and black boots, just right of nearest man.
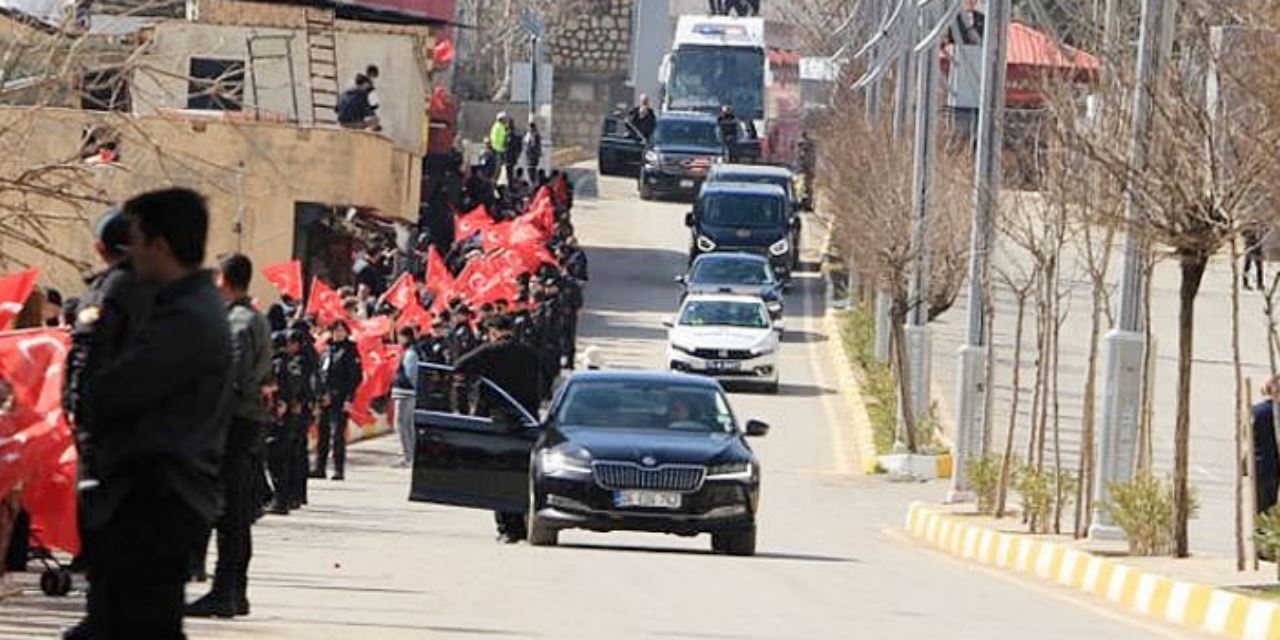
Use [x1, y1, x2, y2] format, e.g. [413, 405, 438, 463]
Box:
[187, 253, 271, 618]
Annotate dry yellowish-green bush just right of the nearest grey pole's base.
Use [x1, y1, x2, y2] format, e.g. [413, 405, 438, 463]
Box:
[1102, 470, 1199, 556]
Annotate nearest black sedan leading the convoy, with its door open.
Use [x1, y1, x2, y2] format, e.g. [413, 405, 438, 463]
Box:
[410, 365, 769, 556]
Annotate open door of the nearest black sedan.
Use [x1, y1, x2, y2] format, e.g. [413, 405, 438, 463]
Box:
[410, 364, 541, 512]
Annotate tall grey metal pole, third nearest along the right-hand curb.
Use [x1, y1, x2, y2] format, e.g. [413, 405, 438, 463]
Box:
[895, 0, 938, 448]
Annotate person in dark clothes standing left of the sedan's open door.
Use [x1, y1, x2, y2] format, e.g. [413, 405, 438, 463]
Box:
[311, 320, 365, 480]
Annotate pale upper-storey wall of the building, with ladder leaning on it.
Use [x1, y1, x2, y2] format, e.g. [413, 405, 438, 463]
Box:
[133, 20, 428, 151]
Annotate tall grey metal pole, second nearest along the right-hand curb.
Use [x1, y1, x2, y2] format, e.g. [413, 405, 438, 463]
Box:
[947, 0, 1010, 502]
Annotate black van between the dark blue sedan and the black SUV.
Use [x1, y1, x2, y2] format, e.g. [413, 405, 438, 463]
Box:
[685, 182, 799, 282]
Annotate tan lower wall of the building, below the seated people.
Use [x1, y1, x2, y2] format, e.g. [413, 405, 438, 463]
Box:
[0, 108, 421, 300]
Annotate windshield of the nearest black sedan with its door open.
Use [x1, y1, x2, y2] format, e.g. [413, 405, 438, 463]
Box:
[557, 380, 735, 433]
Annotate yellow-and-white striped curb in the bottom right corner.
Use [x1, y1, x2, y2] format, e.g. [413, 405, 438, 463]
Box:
[906, 502, 1280, 640]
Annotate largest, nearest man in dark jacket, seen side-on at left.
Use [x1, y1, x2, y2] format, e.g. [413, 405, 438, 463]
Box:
[82, 189, 230, 639]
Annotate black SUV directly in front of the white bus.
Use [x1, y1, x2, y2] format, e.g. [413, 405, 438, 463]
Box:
[640, 111, 724, 200]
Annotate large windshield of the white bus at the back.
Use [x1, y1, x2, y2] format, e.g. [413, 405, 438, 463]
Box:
[668, 46, 764, 119]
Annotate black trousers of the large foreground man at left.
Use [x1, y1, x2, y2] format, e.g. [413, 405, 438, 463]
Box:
[84, 483, 207, 640]
